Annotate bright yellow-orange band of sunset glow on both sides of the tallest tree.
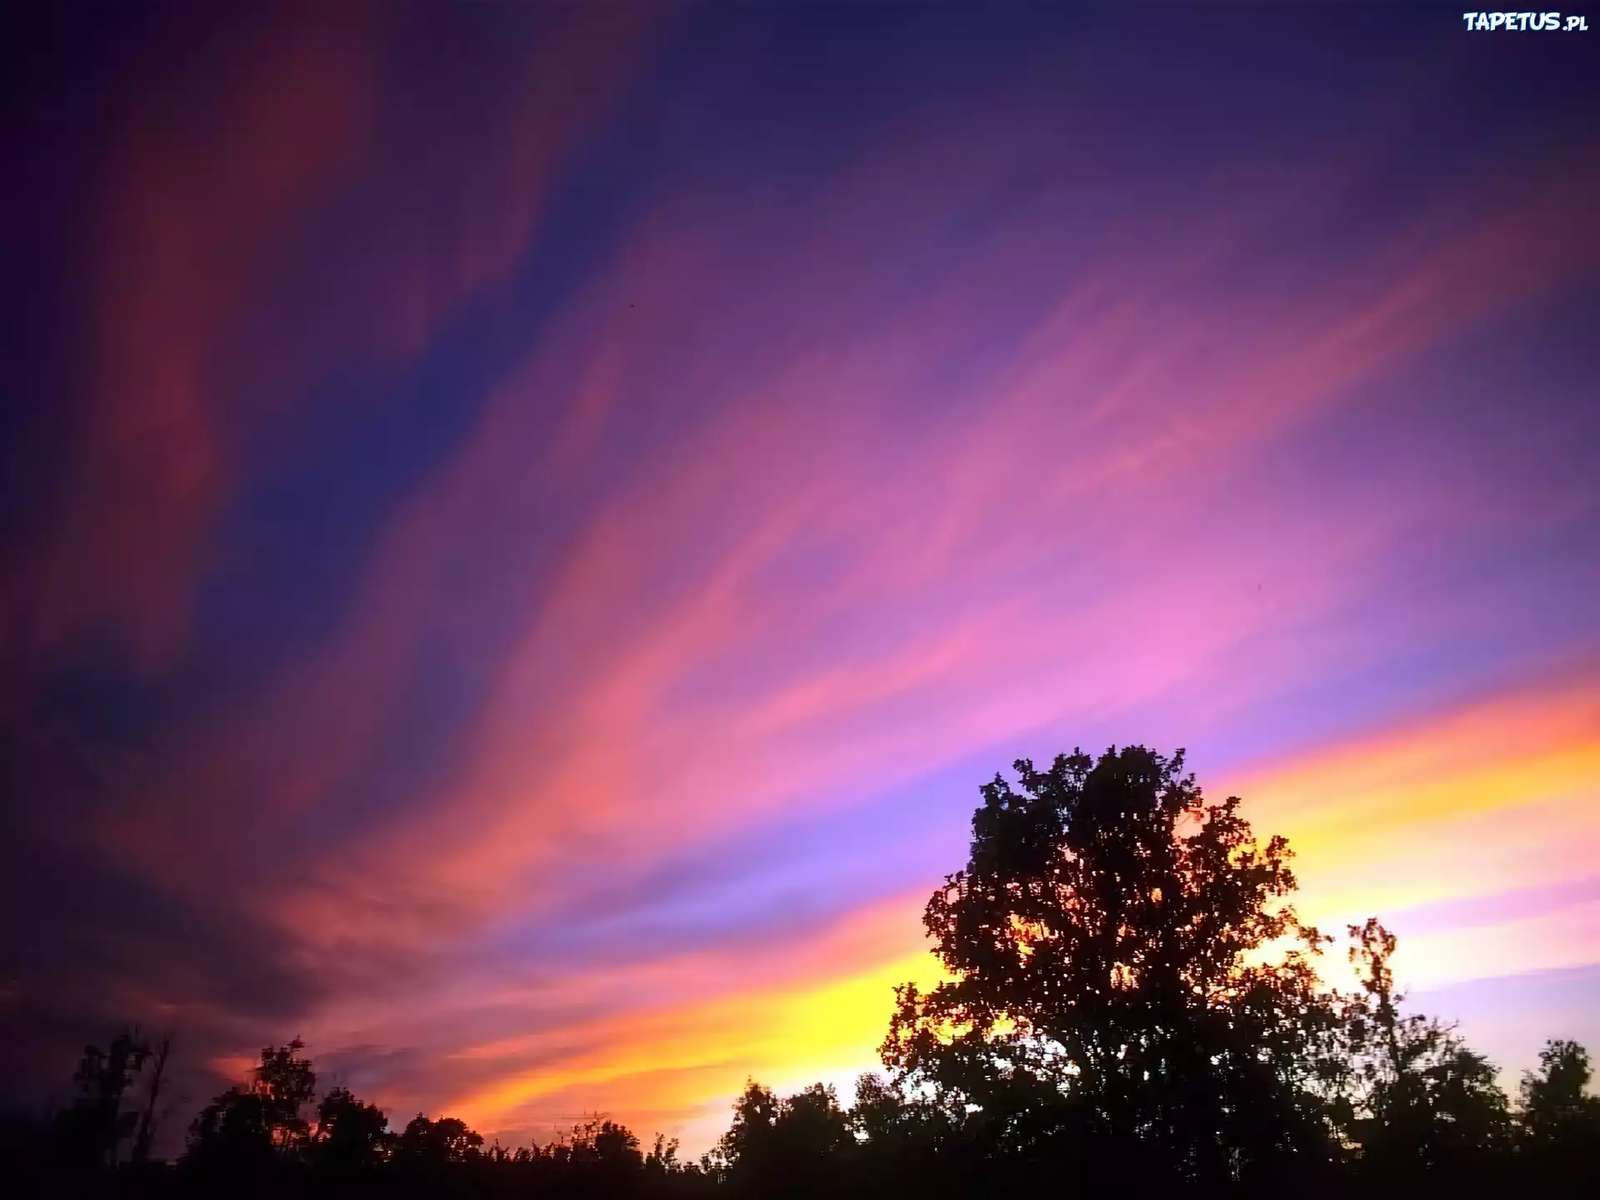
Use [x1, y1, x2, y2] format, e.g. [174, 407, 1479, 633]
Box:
[393, 688, 1600, 1149]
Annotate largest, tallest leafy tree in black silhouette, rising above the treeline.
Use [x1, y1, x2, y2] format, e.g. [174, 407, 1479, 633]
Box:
[883, 746, 1339, 1182]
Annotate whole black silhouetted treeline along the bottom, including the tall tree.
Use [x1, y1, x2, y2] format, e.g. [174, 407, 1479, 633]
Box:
[5, 747, 1600, 1198]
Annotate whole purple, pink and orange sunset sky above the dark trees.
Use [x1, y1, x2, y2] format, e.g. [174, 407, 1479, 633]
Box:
[0, 0, 1600, 1152]
